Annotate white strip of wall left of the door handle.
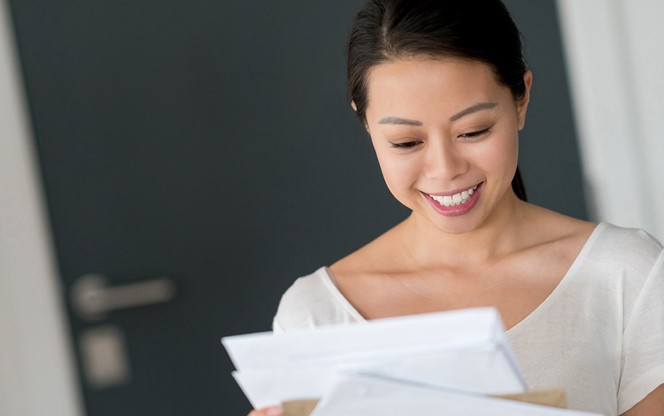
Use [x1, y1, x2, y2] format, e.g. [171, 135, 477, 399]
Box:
[0, 0, 83, 416]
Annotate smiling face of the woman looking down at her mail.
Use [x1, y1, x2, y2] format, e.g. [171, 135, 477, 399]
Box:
[366, 58, 530, 233]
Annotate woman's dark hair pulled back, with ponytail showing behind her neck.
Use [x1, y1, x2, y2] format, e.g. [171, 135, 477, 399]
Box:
[347, 0, 528, 201]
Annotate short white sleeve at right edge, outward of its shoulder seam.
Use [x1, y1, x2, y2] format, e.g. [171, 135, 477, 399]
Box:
[618, 252, 664, 414]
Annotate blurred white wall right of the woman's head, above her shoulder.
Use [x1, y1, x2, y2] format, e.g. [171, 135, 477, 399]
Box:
[558, 0, 664, 241]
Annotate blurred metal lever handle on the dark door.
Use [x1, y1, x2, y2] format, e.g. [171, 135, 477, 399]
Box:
[71, 274, 175, 321]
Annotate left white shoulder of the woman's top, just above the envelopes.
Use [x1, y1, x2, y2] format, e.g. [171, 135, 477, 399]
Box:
[273, 267, 364, 332]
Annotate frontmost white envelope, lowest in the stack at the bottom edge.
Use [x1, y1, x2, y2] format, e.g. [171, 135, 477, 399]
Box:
[311, 376, 601, 416]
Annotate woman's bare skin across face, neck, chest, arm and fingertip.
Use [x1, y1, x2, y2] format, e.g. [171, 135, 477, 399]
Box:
[250, 57, 664, 416]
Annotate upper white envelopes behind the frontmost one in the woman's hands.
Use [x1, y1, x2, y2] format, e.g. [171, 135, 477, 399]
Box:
[222, 308, 525, 407]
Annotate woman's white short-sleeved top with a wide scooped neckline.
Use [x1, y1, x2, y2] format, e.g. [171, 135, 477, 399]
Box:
[274, 223, 664, 416]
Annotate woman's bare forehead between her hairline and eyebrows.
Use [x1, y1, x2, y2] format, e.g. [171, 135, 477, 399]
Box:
[367, 58, 511, 115]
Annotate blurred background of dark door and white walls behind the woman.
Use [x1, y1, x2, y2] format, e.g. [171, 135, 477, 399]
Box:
[0, 0, 664, 416]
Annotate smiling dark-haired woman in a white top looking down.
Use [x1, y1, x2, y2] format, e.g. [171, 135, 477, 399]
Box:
[251, 0, 664, 416]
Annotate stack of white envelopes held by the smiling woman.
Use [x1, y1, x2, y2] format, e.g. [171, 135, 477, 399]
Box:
[222, 308, 600, 416]
